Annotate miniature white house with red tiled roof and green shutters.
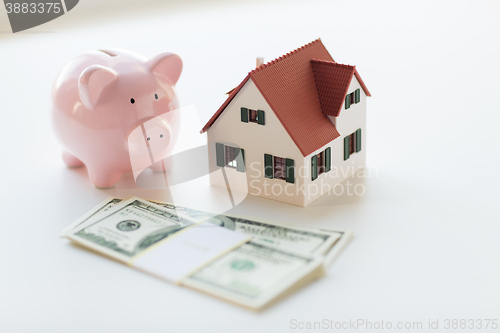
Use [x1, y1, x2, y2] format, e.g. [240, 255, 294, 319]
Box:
[202, 39, 370, 206]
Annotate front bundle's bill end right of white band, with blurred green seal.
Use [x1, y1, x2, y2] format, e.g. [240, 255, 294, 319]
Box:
[183, 242, 324, 309]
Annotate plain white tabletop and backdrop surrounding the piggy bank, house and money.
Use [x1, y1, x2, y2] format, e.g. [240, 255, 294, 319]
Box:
[0, 0, 500, 333]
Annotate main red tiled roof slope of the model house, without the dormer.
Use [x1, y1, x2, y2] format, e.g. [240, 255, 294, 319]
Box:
[201, 39, 368, 156]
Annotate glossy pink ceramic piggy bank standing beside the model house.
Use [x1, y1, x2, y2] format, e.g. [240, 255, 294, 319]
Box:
[52, 49, 182, 188]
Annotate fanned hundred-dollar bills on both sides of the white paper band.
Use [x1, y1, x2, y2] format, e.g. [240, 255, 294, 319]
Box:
[61, 197, 352, 309]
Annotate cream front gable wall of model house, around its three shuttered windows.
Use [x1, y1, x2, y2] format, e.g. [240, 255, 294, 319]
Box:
[207, 79, 306, 206]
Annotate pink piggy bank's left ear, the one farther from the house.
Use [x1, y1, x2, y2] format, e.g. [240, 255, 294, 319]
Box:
[78, 65, 118, 110]
